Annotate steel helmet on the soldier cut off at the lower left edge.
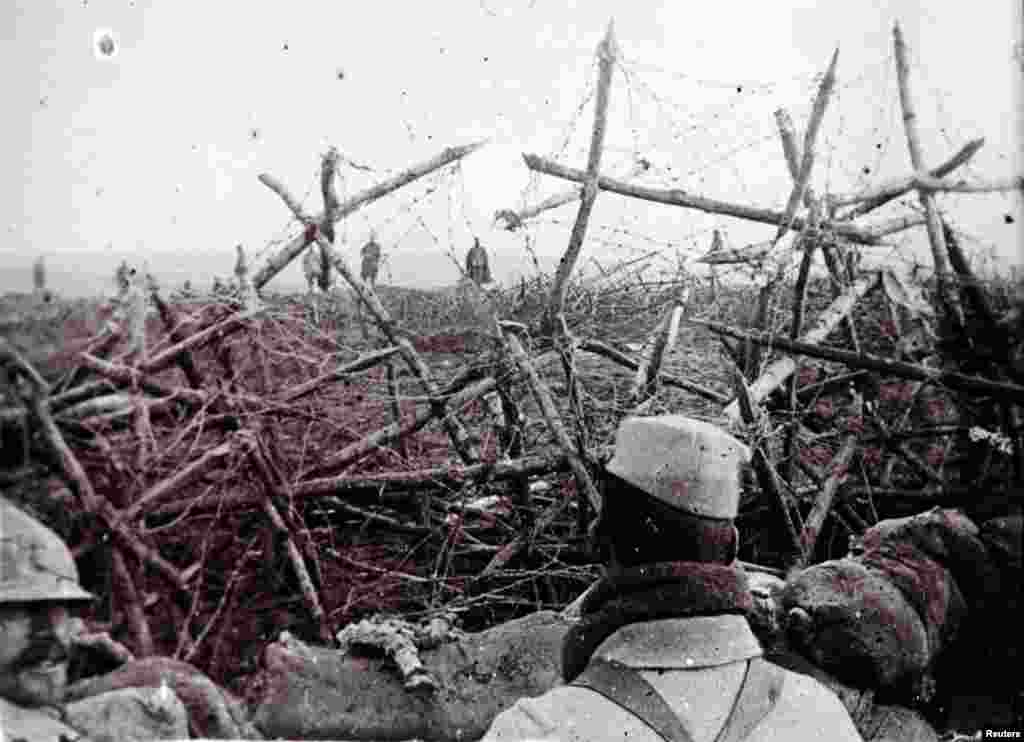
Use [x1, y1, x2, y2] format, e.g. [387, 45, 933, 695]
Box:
[0, 497, 95, 604]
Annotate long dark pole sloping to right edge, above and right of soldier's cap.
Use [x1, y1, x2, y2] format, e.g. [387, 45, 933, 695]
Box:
[689, 319, 1024, 404]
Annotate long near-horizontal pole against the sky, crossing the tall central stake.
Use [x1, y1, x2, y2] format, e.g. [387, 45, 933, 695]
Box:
[523, 155, 909, 246]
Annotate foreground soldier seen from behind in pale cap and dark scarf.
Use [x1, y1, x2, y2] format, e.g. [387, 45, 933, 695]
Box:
[484, 416, 861, 742]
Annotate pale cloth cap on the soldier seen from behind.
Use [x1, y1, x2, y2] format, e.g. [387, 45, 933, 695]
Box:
[607, 414, 751, 520]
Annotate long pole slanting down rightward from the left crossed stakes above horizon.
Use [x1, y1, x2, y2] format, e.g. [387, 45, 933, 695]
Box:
[260, 175, 478, 464]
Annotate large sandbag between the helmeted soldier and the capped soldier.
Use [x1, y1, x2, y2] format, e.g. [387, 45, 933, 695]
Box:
[253, 611, 570, 741]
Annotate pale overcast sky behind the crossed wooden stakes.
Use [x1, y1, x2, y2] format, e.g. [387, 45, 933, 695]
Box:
[0, 0, 1024, 294]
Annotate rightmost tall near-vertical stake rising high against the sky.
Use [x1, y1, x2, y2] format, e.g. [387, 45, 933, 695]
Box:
[893, 24, 964, 328]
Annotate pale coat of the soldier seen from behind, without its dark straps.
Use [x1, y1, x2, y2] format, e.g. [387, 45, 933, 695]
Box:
[483, 615, 861, 742]
